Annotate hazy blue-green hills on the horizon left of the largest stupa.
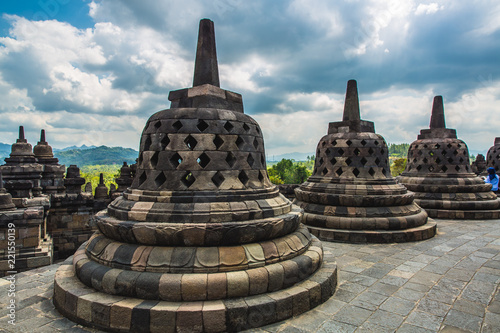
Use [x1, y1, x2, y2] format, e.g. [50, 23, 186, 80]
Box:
[54, 146, 139, 167]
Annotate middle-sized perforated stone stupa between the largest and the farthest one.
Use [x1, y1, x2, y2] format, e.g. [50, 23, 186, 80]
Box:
[295, 80, 436, 243]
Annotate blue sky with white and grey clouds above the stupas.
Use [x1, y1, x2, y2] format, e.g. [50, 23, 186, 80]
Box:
[0, 0, 500, 156]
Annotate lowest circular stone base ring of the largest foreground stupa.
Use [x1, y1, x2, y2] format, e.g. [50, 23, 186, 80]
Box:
[54, 237, 337, 332]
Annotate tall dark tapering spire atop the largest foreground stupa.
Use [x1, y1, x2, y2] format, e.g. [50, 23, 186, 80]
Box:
[193, 19, 220, 87]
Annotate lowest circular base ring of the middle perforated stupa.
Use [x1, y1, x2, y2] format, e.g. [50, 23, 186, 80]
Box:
[307, 220, 437, 243]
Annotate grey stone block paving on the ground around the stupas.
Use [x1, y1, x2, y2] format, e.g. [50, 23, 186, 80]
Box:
[0, 220, 500, 333]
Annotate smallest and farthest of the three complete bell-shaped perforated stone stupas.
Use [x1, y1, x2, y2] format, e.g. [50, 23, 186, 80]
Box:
[399, 96, 500, 219]
